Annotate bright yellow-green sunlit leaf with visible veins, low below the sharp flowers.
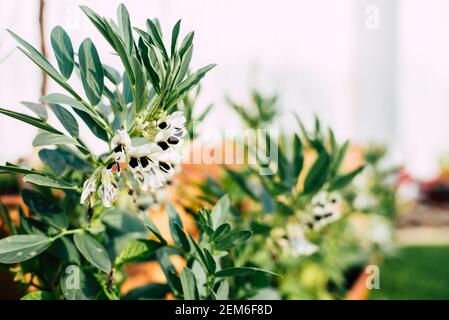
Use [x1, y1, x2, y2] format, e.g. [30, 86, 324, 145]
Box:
[115, 240, 164, 268]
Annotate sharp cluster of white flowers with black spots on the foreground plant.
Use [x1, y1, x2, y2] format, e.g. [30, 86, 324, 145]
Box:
[80, 111, 186, 208]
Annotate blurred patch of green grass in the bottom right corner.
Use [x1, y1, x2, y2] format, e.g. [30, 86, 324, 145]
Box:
[370, 246, 449, 300]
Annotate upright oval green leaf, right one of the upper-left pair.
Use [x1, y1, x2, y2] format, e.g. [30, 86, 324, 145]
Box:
[78, 38, 104, 106]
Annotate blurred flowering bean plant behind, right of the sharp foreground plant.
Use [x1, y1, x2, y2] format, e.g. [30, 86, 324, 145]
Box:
[189, 91, 371, 299]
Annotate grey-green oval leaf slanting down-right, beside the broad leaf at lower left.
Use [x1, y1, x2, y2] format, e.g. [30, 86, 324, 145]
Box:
[73, 232, 112, 273]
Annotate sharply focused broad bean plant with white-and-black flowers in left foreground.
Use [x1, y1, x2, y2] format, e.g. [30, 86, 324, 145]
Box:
[0, 5, 269, 299]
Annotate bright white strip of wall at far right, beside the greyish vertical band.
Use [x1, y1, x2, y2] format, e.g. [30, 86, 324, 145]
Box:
[397, 0, 449, 177]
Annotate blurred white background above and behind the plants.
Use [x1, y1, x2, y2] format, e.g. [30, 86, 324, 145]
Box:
[0, 0, 449, 178]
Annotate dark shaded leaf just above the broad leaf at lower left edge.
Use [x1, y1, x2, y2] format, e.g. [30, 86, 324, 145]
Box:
[22, 189, 69, 229]
